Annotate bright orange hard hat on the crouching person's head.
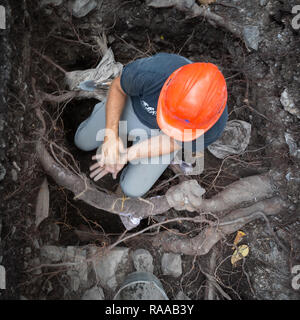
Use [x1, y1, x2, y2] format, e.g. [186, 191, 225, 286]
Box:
[157, 62, 227, 141]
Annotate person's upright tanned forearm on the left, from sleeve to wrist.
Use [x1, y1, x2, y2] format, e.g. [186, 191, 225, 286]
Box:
[105, 77, 126, 136]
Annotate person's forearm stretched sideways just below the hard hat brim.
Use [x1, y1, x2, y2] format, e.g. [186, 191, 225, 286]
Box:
[127, 134, 181, 161]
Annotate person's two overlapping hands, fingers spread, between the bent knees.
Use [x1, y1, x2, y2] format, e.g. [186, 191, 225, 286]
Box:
[90, 137, 128, 181]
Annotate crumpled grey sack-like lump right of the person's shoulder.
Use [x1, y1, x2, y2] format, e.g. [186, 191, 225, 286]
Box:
[208, 120, 251, 159]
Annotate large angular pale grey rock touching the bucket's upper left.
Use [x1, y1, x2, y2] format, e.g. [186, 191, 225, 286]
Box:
[92, 247, 129, 290]
